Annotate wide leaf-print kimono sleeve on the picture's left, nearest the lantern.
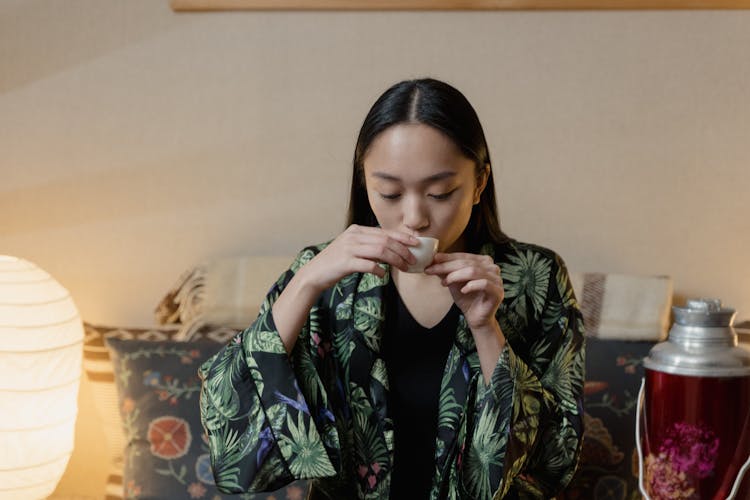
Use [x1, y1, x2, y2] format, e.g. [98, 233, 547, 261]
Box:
[199, 248, 338, 493]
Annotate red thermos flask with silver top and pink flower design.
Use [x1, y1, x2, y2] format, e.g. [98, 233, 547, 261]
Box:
[638, 299, 750, 500]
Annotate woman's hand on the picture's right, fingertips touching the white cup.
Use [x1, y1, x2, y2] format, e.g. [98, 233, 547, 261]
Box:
[424, 253, 504, 332]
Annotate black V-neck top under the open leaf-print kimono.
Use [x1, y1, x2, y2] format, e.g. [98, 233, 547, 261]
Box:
[383, 281, 460, 500]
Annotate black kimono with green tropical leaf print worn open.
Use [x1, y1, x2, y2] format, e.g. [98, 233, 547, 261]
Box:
[200, 241, 584, 500]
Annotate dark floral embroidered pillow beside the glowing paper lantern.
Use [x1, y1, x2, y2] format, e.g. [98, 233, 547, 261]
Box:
[106, 338, 307, 500]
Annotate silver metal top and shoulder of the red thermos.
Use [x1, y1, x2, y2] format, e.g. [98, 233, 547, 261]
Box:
[643, 299, 750, 377]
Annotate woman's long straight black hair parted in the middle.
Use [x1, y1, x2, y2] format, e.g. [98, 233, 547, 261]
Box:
[347, 78, 509, 251]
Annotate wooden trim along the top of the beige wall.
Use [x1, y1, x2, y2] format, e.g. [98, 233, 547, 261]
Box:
[170, 0, 750, 11]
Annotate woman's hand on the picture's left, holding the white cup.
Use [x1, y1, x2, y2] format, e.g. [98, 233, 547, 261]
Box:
[298, 224, 419, 293]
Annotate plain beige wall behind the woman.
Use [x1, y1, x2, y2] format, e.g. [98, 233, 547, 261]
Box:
[0, 0, 750, 495]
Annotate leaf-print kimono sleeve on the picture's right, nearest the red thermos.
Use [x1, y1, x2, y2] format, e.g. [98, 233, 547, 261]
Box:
[456, 252, 584, 499]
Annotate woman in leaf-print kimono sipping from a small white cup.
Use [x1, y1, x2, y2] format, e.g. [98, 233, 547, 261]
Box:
[200, 79, 583, 500]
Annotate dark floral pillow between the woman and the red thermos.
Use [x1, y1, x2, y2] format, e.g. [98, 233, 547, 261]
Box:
[560, 338, 655, 500]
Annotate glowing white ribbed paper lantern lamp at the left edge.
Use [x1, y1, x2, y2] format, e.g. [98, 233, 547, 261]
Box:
[0, 255, 83, 500]
